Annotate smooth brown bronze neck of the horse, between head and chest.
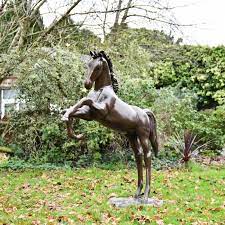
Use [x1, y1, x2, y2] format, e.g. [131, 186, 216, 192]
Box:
[94, 65, 112, 91]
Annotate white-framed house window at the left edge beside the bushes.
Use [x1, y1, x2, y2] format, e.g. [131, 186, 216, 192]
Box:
[0, 89, 19, 119]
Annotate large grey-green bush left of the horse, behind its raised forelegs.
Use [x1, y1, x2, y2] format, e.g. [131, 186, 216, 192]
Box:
[5, 48, 118, 165]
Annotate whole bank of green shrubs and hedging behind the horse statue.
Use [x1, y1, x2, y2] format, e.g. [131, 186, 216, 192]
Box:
[0, 27, 225, 166]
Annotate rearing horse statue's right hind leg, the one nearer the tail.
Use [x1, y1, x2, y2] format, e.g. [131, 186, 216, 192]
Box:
[139, 136, 151, 200]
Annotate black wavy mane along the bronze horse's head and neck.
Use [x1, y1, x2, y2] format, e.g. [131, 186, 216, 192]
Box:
[91, 51, 119, 93]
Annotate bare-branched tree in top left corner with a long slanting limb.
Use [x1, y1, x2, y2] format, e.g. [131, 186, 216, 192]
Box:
[0, 0, 82, 52]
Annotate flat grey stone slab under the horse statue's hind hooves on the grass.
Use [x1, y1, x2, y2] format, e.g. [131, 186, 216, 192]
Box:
[109, 197, 163, 208]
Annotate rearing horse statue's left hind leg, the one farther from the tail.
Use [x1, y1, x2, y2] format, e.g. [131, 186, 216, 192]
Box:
[128, 136, 143, 198]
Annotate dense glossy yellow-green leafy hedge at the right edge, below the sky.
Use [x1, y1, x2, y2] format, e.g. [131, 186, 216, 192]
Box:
[153, 46, 225, 108]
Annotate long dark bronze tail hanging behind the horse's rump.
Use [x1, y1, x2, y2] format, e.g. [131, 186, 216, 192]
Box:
[144, 109, 159, 157]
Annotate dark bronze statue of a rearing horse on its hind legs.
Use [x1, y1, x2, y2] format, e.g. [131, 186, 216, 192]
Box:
[62, 51, 158, 199]
